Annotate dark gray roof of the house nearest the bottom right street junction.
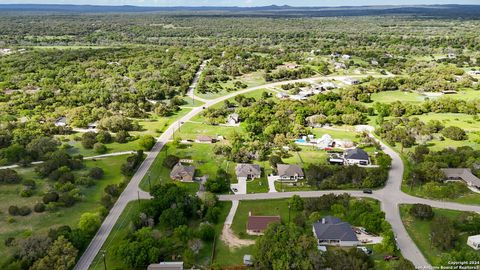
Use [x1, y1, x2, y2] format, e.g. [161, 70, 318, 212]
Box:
[313, 216, 358, 241]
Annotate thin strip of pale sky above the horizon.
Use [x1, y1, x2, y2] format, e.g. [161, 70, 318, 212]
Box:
[0, 0, 480, 6]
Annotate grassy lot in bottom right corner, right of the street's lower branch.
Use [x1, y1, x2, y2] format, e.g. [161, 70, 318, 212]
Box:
[400, 205, 466, 266]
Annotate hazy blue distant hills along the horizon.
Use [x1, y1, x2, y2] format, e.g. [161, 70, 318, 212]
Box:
[0, 4, 480, 18]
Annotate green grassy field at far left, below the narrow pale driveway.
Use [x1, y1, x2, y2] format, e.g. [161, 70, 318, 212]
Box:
[0, 156, 126, 262]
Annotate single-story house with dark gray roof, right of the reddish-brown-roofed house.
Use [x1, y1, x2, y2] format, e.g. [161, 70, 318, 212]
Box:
[312, 216, 360, 247]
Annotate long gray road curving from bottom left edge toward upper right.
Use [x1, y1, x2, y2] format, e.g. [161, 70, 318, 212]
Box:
[74, 70, 420, 270]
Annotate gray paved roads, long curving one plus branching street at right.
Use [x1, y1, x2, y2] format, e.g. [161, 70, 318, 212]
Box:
[74, 67, 464, 270]
